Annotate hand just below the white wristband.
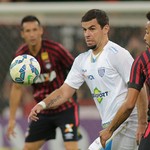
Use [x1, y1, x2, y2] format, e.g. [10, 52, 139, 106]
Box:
[28, 104, 43, 122]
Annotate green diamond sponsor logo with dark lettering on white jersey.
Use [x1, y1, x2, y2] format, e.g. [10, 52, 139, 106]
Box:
[92, 87, 108, 103]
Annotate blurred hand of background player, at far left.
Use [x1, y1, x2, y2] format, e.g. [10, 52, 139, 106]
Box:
[6, 120, 16, 139]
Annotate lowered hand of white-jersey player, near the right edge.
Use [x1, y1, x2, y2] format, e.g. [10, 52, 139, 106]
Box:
[136, 123, 147, 145]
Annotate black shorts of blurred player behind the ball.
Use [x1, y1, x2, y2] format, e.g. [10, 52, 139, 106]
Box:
[25, 107, 79, 142]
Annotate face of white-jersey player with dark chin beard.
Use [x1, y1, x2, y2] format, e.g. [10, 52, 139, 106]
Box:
[82, 19, 109, 50]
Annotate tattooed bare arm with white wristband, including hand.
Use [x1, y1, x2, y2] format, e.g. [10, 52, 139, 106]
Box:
[28, 83, 76, 121]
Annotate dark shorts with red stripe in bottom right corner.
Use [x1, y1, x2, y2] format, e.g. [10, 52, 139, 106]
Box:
[138, 123, 150, 150]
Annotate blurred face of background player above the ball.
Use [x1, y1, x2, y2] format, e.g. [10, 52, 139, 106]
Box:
[21, 21, 43, 46]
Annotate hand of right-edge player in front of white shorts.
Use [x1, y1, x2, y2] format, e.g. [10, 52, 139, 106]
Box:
[99, 128, 112, 148]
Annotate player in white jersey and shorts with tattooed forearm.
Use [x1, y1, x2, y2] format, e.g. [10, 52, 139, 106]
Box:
[29, 9, 147, 150]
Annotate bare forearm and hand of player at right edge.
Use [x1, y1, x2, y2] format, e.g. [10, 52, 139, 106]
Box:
[99, 88, 139, 147]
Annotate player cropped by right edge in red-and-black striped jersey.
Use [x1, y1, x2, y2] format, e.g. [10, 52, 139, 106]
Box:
[100, 12, 150, 150]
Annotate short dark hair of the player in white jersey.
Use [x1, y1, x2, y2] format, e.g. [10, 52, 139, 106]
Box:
[81, 9, 109, 28]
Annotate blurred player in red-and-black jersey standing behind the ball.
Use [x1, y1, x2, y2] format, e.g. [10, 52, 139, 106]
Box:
[7, 16, 79, 150]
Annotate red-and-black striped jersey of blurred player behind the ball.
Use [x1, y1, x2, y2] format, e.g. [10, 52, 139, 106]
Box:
[16, 40, 77, 114]
